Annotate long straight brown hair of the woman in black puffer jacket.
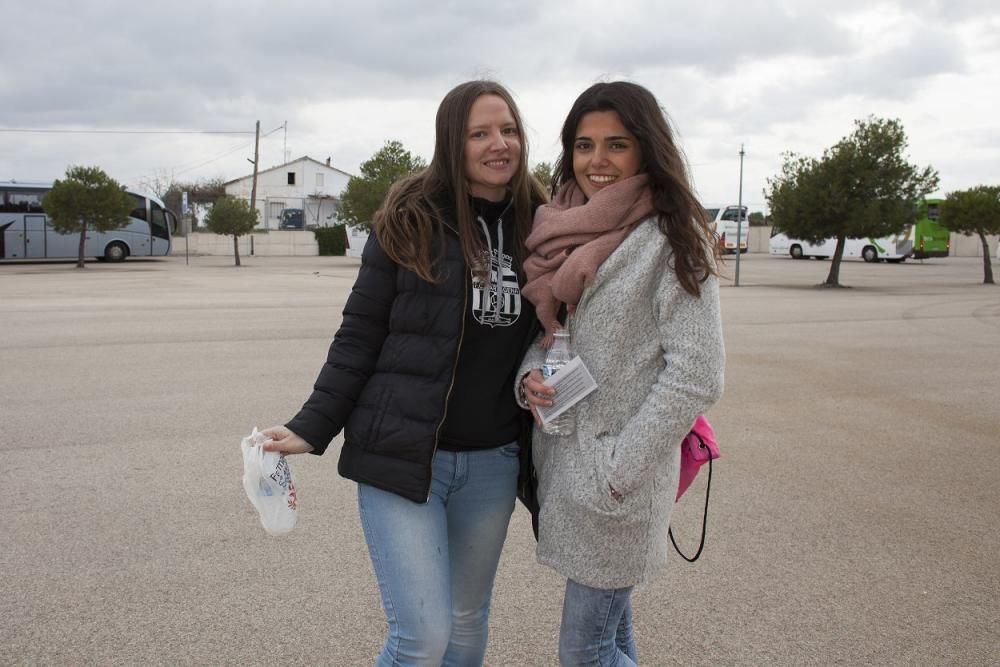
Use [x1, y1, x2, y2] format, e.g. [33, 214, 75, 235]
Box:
[374, 80, 546, 282]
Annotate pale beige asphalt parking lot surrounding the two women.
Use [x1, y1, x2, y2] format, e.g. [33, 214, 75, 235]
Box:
[0, 255, 1000, 665]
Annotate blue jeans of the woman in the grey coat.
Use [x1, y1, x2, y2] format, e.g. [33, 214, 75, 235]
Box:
[559, 579, 639, 667]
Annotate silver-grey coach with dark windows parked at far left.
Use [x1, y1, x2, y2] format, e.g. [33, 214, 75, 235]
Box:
[0, 181, 177, 262]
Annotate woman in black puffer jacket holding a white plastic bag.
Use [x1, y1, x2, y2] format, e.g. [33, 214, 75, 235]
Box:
[264, 81, 544, 665]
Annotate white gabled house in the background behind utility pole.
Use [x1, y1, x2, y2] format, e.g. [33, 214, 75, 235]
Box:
[224, 155, 351, 229]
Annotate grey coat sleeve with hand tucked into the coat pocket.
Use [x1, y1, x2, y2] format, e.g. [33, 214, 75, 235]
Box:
[602, 277, 725, 495]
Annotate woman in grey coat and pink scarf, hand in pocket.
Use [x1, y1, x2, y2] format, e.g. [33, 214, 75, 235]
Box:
[517, 82, 725, 665]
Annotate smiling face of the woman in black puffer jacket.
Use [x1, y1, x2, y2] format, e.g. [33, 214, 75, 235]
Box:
[465, 95, 521, 201]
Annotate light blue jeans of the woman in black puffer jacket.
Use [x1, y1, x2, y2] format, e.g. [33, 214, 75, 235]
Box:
[358, 443, 519, 667]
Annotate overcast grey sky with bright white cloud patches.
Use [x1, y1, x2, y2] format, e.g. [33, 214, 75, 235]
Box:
[0, 0, 1000, 209]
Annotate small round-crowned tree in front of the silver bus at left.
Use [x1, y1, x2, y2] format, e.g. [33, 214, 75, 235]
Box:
[42, 166, 135, 269]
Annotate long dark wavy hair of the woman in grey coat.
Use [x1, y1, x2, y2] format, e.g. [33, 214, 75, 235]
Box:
[552, 81, 721, 296]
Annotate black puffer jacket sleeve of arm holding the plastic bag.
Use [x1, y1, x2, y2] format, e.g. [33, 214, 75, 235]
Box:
[286, 234, 398, 454]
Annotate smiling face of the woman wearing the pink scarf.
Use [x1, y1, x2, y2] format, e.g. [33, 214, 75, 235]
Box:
[573, 111, 642, 199]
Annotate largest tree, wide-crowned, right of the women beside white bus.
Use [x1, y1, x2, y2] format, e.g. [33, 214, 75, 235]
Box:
[765, 117, 938, 287]
